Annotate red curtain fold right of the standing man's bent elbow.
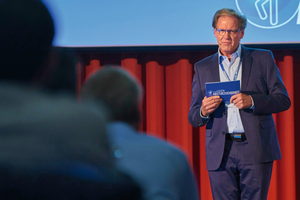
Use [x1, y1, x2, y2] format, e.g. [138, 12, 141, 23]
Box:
[271, 55, 296, 200]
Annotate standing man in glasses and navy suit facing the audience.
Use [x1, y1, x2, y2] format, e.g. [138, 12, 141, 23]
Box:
[188, 9, 291, 200]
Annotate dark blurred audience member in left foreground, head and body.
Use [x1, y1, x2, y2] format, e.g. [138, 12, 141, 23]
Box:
[0, 0, 140, 200]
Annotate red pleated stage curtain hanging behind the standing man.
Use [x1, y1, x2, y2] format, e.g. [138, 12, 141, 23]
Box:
[78, 49, 300, 200]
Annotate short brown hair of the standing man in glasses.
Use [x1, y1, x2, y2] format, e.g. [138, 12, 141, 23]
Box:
[212, 8, 247, 30]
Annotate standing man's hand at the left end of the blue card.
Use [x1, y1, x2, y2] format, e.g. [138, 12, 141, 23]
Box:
[201, 96, 223, 117]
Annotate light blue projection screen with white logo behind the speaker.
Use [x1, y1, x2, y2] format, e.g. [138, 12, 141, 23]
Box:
[43, 0, 300, 47]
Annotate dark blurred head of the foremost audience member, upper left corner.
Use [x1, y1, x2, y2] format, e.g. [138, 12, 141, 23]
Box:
[0, 0, 55, 81]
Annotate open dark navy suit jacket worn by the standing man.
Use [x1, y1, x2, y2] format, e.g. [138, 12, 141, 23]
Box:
[188, 45, 291, 170]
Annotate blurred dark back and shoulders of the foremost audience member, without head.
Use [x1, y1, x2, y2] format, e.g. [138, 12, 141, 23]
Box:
[0, 87, 139, 200]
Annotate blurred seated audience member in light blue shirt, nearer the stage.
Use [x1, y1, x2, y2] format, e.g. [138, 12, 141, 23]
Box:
[82, 67, 199, 200]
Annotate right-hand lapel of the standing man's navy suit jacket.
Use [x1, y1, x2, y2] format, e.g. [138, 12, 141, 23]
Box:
[241, 46, 253, 91]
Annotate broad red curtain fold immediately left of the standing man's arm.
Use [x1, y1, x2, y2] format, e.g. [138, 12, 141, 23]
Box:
[166, 59, 193, 164]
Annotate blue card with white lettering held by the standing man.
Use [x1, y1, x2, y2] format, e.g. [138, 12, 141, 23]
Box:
[205, 80, 241, 103]
